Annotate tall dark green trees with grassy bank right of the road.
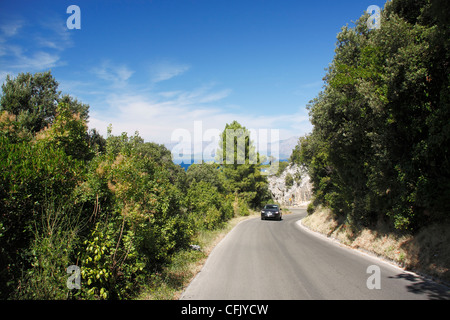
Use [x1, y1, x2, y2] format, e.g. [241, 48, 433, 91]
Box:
[291, 0, 450, 279]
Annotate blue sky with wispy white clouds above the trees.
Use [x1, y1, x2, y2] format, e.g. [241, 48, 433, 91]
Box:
[0, 0, 385, 143]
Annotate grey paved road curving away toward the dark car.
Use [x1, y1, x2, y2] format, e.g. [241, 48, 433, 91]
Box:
[181, 209, 450, 300]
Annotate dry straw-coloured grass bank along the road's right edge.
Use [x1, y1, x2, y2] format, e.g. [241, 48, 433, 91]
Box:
[303, 207, 450, 282]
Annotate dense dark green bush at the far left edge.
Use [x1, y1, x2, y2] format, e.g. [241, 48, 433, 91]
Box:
[0, 135, 83, 297]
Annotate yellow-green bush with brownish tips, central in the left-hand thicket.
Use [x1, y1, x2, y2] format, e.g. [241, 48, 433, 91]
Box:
[76, 129, 193, 299]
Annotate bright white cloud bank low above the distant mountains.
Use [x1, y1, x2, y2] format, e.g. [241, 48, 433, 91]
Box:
[89, 82, 311, 150]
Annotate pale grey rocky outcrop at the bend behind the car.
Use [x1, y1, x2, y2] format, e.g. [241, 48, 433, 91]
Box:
[268, 164, 312, 206]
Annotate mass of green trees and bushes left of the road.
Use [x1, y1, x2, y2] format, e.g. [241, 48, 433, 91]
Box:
[0, 72, 270, 299]
